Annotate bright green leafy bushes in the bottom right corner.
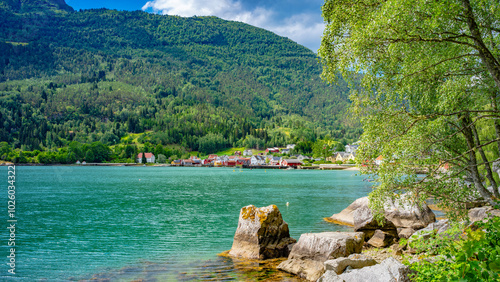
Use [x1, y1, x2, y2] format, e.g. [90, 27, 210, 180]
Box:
[410, 217, 500, 281]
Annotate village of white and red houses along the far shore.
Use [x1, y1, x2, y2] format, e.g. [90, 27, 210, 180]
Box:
[133, 144, 359, 169]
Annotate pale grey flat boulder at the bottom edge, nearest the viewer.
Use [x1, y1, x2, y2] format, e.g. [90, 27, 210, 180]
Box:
[318, 257, 410, 282]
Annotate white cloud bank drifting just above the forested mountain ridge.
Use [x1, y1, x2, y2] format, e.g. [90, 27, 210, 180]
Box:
[142, 0, 324, 52]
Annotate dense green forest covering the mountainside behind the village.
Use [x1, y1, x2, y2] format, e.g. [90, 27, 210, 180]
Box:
[0, 0, 361, 162]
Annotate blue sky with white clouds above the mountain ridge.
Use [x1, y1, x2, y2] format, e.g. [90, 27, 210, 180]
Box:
[66, 0, 324, 52]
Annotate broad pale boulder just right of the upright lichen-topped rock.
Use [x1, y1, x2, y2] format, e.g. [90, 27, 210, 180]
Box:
[278, 232, 364, 281]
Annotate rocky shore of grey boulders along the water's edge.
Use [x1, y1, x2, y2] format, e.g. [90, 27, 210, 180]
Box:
[226, 195, 500, 282]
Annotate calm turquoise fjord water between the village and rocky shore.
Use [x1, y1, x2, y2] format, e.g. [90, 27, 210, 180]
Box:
[0, 166, 371, 281]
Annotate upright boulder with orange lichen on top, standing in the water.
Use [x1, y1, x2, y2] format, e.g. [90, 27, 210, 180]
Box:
[229, 205, 296, 259]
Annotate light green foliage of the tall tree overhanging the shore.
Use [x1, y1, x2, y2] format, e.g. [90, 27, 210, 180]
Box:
[319, 0, 500, 218]
